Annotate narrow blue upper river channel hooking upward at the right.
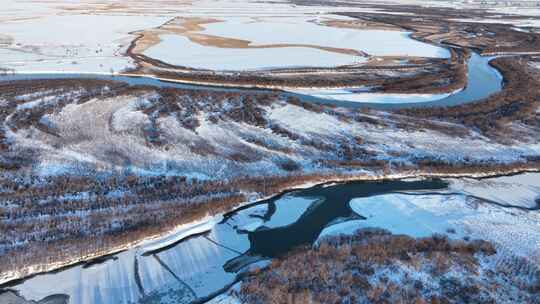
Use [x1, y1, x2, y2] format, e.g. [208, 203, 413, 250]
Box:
[0, 53, 503, 109]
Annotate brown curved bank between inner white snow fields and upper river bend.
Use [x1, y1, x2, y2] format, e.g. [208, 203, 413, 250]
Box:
[121, 13, 466, 94]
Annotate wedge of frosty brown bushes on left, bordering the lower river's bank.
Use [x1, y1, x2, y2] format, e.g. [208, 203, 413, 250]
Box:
[0, 173, 346, 273]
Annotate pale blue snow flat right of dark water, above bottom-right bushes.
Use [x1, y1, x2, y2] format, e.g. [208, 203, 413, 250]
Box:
[351, 194, 540, 262]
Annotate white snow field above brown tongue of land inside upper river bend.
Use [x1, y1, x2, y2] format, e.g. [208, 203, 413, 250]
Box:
[203, 16, 450, 58]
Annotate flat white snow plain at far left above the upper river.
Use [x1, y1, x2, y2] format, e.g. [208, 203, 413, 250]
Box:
[0, 12, 167, 73]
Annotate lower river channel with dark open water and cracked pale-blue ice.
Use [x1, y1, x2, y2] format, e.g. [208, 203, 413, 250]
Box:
[4, 173, 540, 304]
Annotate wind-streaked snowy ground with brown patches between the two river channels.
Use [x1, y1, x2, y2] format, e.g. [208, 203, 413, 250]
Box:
[7, 91, 540, 179]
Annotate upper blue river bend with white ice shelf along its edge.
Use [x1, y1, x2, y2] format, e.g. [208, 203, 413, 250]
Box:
[0, 49, 502, 109]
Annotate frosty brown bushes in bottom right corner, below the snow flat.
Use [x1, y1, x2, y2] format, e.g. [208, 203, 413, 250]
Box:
[236, 229, 540, 303]
